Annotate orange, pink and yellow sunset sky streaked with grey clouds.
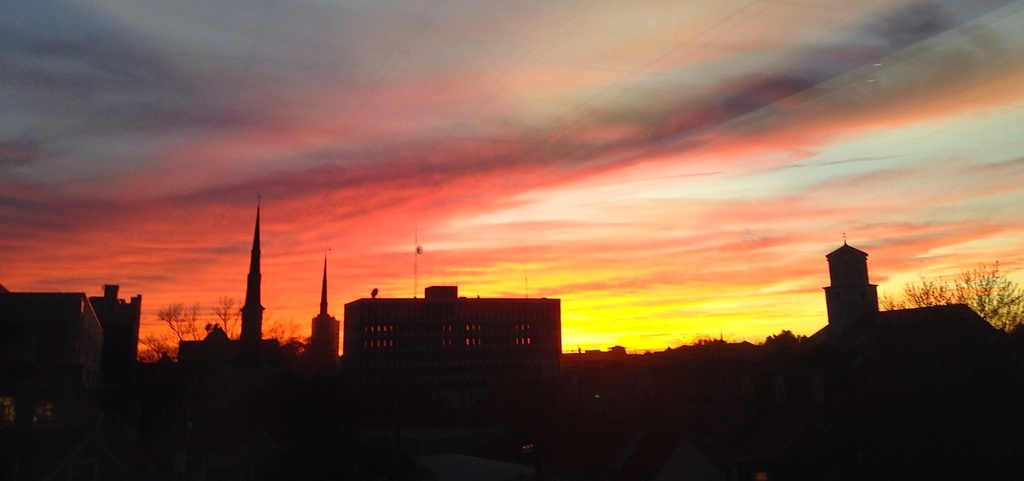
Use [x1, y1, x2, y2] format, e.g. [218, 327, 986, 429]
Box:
[0, 0, 1024, 351]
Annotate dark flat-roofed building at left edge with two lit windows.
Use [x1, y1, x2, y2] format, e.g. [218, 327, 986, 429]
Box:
[0, 292, 103, 431]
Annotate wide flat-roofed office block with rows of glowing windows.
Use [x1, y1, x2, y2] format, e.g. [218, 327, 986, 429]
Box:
[342, 287, 562, 388]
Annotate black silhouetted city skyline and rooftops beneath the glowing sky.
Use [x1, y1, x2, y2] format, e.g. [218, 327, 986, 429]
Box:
[0, 242, 1024, 481]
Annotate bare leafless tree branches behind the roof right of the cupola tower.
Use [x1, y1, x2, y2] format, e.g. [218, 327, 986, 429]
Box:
[879, 262, 1024, 332]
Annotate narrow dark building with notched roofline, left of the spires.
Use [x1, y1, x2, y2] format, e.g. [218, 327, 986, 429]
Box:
[89, 285, 142, 384]
